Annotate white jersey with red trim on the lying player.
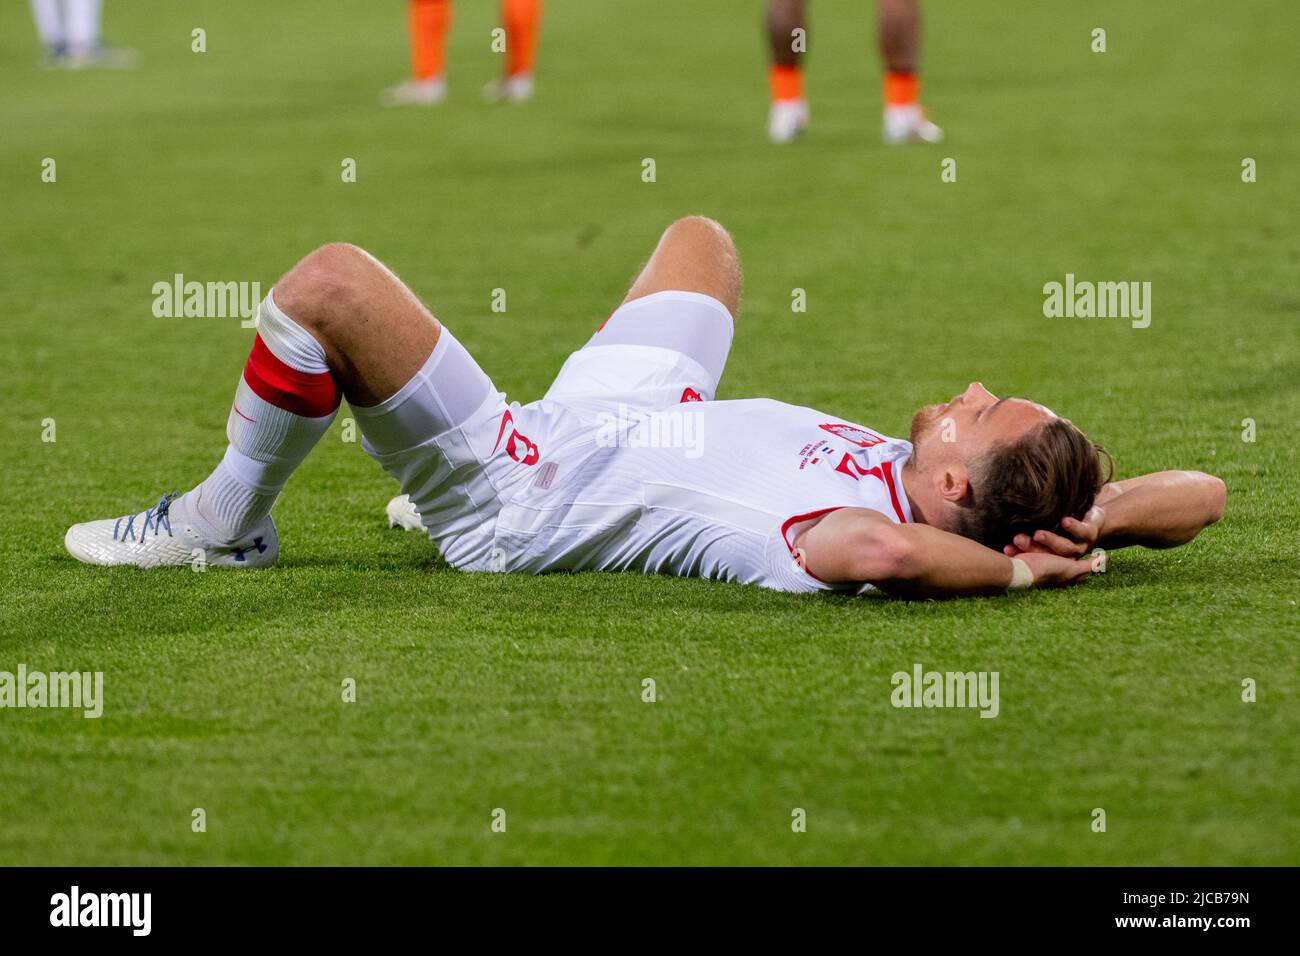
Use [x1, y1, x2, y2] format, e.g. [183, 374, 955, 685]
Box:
[495, 398, 911, 592]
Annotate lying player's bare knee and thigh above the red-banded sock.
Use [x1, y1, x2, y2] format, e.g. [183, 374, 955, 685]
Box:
[272, 242, 441, 406]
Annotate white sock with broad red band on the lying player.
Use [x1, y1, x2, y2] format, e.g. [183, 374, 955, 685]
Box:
[182, 290, 339, 544]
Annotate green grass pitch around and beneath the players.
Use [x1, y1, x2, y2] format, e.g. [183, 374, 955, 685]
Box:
[0, 0, 1300, 865]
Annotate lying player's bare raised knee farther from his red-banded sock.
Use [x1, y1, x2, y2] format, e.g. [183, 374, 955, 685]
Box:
[623, 216, 744, 319]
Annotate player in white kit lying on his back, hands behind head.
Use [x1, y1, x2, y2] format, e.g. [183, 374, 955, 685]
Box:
[65, 217, 1225, 596]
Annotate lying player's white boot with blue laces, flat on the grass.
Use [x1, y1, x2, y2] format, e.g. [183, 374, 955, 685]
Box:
[64, 493, 280, 567]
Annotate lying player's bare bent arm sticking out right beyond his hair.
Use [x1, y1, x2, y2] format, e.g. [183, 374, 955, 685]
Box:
[1097, 471, 1227, 549]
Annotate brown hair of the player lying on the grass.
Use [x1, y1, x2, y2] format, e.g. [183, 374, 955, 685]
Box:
[956, 419, 1115, 550]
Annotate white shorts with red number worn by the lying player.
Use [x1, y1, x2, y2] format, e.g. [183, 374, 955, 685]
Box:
[354, 291, 733, 571]
